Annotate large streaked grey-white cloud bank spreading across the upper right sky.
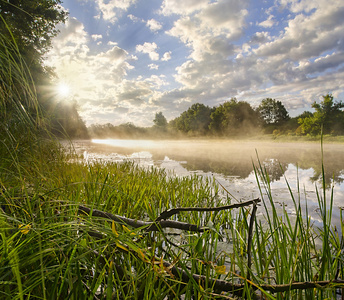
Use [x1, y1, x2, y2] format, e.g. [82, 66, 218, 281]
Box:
[160, 1, 344, 115]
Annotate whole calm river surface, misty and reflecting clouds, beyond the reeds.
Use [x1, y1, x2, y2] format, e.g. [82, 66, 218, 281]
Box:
[71, 139, 344, 225]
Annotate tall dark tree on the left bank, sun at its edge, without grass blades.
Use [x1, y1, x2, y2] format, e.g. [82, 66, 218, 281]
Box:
[0, 0, 91, 137]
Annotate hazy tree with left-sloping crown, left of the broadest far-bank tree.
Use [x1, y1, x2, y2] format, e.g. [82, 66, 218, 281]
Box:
[170, 103, 212, 135]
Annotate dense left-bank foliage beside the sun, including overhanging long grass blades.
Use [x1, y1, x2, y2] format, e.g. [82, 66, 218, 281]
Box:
[0, 0, 87, 137]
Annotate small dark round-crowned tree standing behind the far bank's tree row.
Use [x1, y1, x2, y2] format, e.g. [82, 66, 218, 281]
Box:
[257, 98, 289, 125]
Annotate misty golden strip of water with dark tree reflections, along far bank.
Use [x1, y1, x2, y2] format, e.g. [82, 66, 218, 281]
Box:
[88, 140, 344, 185]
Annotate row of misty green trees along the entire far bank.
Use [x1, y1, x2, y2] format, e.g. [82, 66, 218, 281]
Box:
[88, 94, 344, 138]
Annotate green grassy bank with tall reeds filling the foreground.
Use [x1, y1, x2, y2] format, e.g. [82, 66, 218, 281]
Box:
[0, 142, 343, 299]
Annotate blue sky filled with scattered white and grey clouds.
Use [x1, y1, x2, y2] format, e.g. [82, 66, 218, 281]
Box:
[46, 0, 344, 126]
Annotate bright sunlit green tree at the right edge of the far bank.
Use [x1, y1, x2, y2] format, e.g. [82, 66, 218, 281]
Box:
[299, 94, 344, 135]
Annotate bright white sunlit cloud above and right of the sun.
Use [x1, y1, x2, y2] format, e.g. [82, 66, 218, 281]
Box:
[46, 18, 141, 120]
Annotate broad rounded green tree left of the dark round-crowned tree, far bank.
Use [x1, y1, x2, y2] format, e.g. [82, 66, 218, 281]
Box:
[209, 98, 259, 134]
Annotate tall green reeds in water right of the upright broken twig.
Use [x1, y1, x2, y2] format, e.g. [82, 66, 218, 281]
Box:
[243, 151, 344, 299]
